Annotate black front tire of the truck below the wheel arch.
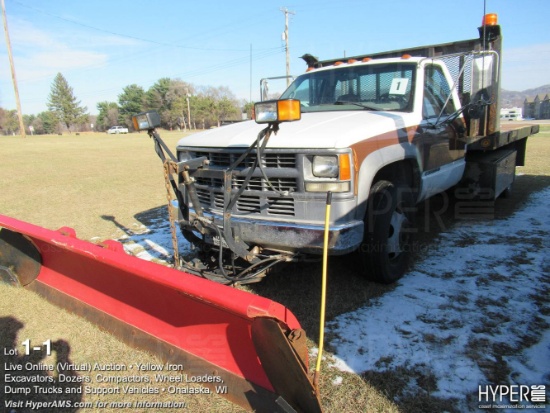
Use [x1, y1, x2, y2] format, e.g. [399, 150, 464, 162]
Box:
[359, 180, 416, 284]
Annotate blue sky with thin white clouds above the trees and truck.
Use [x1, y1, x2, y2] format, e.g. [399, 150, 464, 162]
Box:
[0, 0, 550, 114]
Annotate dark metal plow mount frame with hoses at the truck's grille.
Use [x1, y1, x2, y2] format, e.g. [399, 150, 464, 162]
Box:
[134, 109, 299, 284]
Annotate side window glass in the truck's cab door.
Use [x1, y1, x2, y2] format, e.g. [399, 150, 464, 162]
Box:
[422, 65, 455, 119]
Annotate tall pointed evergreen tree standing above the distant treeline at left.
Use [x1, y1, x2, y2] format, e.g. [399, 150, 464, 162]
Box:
[47, 73, 88, 133]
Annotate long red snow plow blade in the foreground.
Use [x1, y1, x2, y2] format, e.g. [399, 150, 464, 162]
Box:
[0, 215, 321, 412]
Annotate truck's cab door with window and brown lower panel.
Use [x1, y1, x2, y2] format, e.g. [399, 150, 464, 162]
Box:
[415, 64, 465, 173]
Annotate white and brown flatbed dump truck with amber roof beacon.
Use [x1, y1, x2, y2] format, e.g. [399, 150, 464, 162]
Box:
[138, 14, 538, 284]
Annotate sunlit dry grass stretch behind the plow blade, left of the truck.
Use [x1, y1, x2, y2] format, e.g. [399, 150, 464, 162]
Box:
[0, 132, 190, 239]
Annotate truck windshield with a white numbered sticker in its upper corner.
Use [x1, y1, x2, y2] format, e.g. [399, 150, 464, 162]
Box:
[280, 62, 416, 112]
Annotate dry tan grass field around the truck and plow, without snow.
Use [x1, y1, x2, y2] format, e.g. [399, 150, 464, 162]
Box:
[0, 126, 550, 412]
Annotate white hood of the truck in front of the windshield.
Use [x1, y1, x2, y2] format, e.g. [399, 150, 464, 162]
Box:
[178, 110, 419, 149]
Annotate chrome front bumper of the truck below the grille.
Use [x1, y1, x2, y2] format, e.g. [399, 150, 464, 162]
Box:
[172, 201, 364, 255]
